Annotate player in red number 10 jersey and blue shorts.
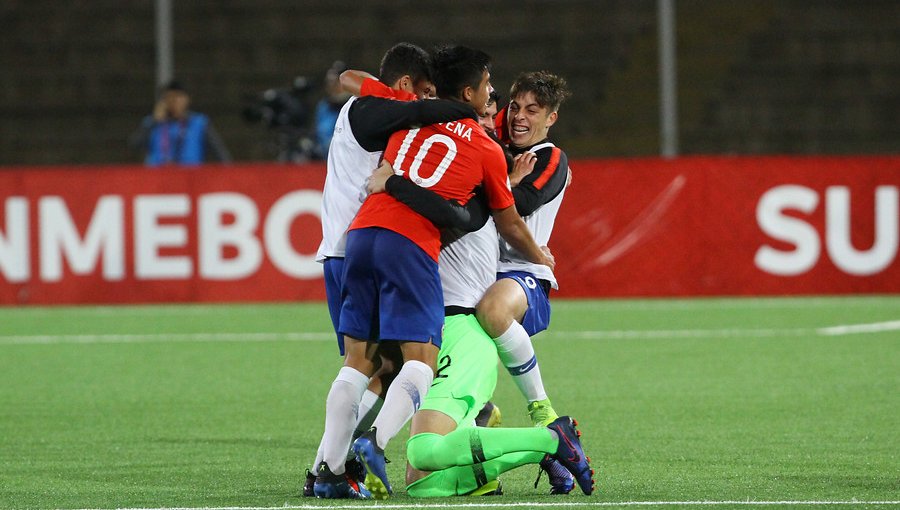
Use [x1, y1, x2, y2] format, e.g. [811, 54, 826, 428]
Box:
[316, 46, 553, 498]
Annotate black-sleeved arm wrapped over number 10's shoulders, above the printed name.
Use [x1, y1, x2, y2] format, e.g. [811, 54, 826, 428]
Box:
[349, 96, 476, 152]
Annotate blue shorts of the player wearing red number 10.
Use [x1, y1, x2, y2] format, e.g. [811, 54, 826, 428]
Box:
[338, 227, 444, 347]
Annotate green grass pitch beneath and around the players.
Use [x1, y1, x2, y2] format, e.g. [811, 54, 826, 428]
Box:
[0, 297, 900, 509]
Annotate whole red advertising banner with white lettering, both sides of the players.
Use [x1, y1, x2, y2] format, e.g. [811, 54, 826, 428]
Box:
[0, 157, 900, 305]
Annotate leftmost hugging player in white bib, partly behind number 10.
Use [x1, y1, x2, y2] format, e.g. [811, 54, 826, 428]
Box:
[312, 43, 486, 498]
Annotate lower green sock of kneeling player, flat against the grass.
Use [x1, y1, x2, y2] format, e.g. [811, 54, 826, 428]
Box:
[406, 452, 545, 498]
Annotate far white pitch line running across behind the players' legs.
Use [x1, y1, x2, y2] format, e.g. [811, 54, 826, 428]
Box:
[0, 321, 900, 345]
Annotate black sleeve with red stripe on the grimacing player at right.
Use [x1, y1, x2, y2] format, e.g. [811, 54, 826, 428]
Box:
[513, 147, 569, 216]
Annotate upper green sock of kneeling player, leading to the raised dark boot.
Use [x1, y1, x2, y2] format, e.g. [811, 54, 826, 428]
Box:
[406, 427, 559, 471]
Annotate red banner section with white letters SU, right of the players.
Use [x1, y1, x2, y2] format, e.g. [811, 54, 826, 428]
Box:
[551, 157, 900, 297]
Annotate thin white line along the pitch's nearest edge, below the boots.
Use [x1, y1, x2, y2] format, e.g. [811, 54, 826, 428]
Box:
[70, 500, 900, 510]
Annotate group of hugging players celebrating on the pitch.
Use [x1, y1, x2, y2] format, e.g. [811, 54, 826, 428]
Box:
[303, 43, 594, 499]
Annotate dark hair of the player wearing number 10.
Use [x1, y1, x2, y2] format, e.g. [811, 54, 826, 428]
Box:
[431, 46, 491, 99]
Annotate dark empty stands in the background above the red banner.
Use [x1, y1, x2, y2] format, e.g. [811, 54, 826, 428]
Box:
[0, 0, 900, 165]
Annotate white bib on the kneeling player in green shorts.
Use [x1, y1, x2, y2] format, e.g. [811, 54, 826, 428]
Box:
[438, 218, 500, 308]
